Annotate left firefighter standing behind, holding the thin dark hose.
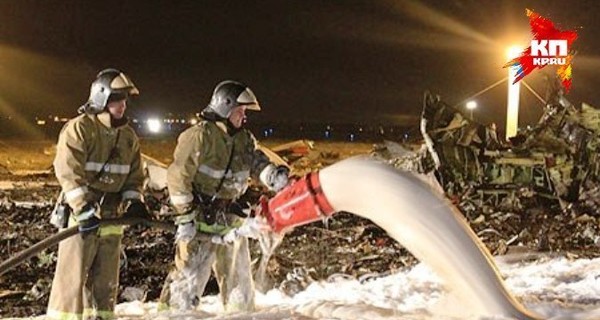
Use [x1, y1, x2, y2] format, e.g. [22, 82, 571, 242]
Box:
[47, 69, 148, 319]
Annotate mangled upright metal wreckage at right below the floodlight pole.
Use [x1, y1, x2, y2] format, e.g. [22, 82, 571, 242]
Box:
[390, 79, 600, 214]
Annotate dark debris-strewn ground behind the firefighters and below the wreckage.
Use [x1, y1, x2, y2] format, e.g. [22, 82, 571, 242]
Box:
[0, 139, 600, 317]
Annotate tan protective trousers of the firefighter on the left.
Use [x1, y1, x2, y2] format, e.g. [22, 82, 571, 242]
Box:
[47, 227, 122, 320]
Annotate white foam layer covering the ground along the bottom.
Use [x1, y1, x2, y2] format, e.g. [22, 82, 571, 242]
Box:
[105, 257, 600, 320]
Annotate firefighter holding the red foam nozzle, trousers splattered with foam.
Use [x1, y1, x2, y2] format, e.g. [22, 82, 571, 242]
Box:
[159, 80, 289, 312]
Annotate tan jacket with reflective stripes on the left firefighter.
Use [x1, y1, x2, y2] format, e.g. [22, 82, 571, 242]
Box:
[54, 112, 144, 213]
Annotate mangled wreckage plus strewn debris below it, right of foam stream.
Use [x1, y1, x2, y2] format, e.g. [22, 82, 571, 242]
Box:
[373, 80, 600, 256]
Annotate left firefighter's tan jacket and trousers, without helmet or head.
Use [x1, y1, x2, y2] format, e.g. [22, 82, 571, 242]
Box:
[46, 112, 143, 320]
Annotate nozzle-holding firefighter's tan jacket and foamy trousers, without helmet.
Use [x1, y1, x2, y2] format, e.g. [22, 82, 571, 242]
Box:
[160, 120, 272, 311]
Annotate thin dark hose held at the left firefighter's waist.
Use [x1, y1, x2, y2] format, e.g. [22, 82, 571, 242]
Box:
[0, 217, 176, 276]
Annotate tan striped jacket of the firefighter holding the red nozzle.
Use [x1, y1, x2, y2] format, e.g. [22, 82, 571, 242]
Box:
[167, 121, 270, 213]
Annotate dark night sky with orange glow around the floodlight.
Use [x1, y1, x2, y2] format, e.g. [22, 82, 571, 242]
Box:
[0, 0, 600, 129]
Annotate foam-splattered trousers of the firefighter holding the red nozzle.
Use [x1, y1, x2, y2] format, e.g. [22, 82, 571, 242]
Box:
[160, 233, 255, 312]
